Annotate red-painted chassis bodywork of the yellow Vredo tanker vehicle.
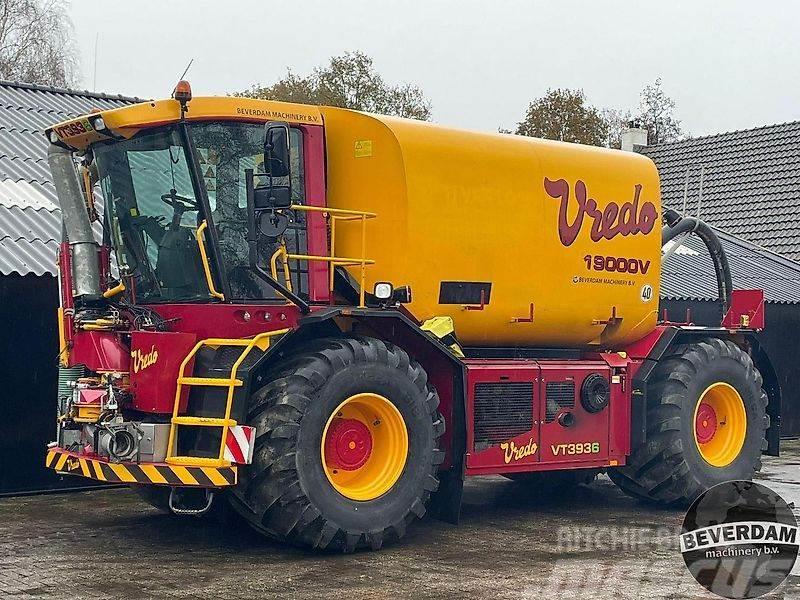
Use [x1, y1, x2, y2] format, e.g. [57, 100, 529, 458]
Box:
[57, 258, 763, 482]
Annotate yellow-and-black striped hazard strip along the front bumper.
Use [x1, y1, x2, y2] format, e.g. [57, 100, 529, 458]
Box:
[44, 448, 238, 487]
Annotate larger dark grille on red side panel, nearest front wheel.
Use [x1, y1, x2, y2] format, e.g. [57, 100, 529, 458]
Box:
[475, 381, 533, 447]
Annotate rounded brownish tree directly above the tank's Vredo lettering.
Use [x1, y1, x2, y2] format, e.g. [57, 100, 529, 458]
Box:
[515, 89, 608, 146]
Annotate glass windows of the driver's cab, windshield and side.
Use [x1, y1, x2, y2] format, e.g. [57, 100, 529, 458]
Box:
[94, 122, 307, 303]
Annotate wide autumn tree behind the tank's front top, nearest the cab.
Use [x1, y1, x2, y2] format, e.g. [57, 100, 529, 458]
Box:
[235, 51, 431, 121]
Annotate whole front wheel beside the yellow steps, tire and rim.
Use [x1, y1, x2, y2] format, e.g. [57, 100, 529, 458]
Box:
[231, 337, 444, 552]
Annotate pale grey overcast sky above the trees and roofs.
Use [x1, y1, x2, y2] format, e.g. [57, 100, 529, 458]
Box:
[69, 0, 800, 136]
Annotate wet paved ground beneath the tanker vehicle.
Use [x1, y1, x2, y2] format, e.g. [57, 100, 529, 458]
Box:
[0, 442, 800, 600]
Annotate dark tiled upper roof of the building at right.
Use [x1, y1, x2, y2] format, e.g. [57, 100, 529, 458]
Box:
[641, 121, 800, 260]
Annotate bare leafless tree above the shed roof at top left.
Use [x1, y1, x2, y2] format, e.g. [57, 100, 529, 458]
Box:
[0, 0, 78, 87]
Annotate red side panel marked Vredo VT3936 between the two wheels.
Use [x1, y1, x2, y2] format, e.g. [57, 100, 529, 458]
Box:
[465, 355, 630, 475]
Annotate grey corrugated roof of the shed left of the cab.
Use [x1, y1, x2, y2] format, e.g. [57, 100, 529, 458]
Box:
[0, 81, 142, 275]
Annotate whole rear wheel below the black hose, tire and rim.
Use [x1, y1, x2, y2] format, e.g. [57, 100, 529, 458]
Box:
[608, 338, 769, 506]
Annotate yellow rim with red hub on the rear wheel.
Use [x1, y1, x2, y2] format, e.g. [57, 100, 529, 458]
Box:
[694, 381, 747, 467]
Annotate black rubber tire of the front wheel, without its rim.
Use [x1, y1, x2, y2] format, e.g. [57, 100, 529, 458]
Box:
[230, 337, 444, 552]
